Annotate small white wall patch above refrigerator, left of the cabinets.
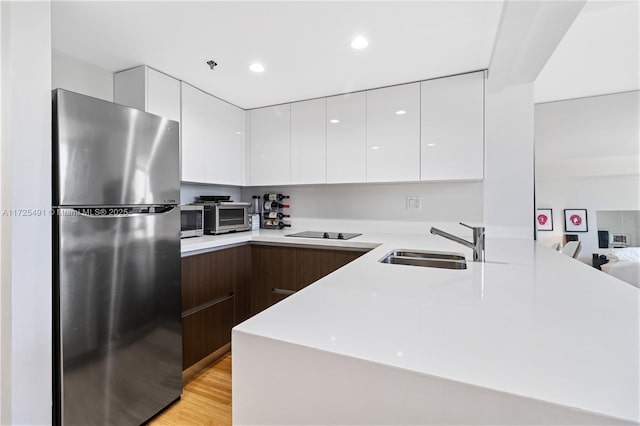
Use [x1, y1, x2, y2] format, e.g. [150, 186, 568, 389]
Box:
[51, 49, 113, 102]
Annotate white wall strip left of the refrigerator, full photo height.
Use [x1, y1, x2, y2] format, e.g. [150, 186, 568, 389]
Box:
[0, 1, 52, 425]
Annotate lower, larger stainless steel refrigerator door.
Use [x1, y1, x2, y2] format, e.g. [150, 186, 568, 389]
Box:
[54, 206, 182, 425]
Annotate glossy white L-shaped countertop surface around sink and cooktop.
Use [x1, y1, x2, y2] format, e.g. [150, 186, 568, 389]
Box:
[182, 229, 640, 422]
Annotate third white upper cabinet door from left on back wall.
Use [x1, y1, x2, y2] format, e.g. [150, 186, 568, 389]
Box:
[327, 92, 367, 183]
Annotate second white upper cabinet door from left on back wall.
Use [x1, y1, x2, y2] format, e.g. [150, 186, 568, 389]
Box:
[291, 99, 327, 184]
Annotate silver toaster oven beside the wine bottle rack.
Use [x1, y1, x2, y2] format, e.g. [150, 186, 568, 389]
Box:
[202, 201, 251, 234]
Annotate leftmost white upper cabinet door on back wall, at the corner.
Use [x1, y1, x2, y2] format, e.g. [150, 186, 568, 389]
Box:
[249, 104, 291, 186]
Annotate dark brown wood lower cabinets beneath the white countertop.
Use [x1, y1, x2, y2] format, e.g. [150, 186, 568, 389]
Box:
[182, 244, 365, 369]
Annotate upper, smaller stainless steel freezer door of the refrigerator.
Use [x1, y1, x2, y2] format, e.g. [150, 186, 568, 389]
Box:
[53, 89, 180, 206]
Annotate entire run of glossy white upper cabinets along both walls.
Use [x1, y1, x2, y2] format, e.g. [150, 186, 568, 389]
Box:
[114, 66, 485, 186]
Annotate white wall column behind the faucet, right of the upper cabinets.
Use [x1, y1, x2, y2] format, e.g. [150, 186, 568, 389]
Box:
[484, 83, 534, 239]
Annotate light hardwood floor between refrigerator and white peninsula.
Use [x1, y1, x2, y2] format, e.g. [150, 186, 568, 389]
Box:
[149, 353, 231, 426]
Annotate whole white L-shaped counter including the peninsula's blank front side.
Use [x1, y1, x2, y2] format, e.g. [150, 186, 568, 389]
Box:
[182, 231, 640, 424]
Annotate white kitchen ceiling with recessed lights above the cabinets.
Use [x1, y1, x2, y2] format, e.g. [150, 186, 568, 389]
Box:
[52, 1, 503, 108]
